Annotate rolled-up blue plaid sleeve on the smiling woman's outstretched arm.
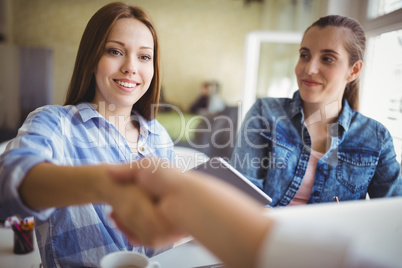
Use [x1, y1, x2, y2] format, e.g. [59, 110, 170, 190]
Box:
[0, 106, 61, 219]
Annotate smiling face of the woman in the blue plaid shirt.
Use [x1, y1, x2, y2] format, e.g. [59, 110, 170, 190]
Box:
[94, 18, 154, 110]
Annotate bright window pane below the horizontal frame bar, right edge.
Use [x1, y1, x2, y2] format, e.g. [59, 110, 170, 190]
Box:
[361, 30, 402, 162]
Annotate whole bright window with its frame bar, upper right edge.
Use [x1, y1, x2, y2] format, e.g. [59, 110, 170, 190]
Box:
[360, 0, 402, 163]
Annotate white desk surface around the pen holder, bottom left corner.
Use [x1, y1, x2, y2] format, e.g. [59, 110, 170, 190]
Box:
[0, 228, 42, 268]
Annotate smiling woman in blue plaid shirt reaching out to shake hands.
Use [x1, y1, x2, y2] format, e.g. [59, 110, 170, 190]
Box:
[0, 3, 177, 267]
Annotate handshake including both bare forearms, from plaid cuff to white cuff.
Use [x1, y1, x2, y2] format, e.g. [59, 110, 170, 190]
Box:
[19, 158, 272, 267]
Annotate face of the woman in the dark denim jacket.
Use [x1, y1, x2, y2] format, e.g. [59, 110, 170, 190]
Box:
[295, 26, 354, 105]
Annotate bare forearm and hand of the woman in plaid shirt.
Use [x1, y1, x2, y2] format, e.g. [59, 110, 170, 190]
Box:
[19, 163, 175, 246]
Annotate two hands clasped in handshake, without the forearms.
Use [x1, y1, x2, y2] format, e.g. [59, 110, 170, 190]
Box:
[103, 159, 185, 247]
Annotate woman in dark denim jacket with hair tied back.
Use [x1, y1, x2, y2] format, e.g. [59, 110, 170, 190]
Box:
[231, 15, 402, 206]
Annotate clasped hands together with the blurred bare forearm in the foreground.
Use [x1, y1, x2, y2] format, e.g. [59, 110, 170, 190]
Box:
[103, 158, 272, 267]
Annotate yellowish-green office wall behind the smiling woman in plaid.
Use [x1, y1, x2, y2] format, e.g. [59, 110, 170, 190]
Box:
[8, 0, 262, 108]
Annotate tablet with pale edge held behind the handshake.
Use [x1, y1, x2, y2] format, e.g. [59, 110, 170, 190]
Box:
[192, 157, 272, 206]
